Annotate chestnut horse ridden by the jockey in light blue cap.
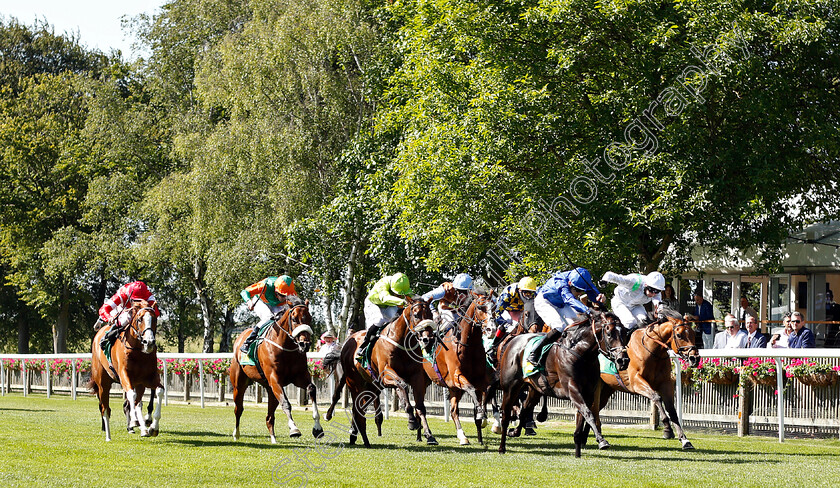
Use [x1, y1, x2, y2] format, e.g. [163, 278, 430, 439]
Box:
[423, 294, 495, 446]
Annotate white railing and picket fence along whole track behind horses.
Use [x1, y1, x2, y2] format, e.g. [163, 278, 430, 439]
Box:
[0, 349, 840, 442]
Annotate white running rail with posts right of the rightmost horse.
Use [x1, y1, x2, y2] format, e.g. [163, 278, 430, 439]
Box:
[669, 348, 840, 442]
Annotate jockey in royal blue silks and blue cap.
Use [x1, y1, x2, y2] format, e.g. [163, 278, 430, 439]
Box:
[524, 267, 604, 376]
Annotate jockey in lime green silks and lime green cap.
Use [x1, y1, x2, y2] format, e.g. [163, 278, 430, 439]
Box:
[356, 273, 412, 359]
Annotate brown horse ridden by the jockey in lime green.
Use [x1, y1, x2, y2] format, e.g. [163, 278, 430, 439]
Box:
[323, 298, 438, 447]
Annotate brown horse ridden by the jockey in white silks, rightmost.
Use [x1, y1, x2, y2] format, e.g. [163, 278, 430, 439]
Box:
[578, 309, 700, 449]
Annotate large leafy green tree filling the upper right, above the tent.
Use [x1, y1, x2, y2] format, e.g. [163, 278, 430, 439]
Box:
[383, 1, 840, 278]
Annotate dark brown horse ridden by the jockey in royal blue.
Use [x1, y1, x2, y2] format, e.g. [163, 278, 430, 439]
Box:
[499, 312, 629, 457]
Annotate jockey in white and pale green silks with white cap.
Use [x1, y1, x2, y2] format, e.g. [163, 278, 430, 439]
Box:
[601, 271, 665, 331]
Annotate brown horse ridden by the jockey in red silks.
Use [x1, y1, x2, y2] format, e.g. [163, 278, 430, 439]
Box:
[89, 300, 163, 441]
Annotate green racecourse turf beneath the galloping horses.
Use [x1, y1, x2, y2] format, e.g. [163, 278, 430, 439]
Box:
[0, 394, 840, 488]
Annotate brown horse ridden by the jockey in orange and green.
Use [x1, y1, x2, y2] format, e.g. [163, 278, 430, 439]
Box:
[230, 297, 324, 444]
